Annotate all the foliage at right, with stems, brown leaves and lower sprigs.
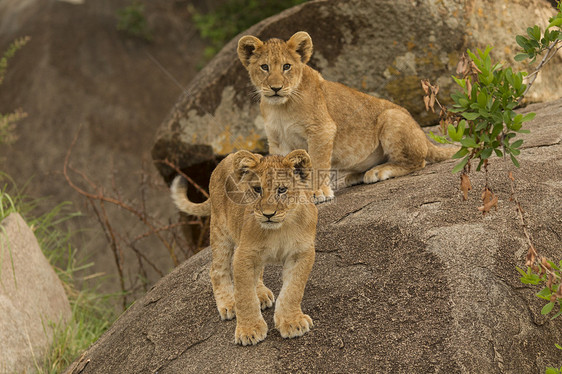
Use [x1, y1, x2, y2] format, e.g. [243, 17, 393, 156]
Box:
[422, 1, 562, 374]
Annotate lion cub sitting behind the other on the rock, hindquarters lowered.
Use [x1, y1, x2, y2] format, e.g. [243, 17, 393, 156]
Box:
[238, 31, 457, 202]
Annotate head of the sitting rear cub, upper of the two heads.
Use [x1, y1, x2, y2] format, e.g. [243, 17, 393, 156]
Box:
[234, 31, 312, 104]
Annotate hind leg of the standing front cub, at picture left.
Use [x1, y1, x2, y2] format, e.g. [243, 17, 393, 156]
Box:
[211, 225, 234, 320]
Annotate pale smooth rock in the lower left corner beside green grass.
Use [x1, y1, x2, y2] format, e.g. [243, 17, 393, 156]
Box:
[0, 213, 70, 373]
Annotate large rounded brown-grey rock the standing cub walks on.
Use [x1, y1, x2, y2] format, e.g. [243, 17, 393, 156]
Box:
[67, 100, 562, 374]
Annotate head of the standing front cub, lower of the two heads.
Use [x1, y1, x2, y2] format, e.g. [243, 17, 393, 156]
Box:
[227, 149, 314, 229]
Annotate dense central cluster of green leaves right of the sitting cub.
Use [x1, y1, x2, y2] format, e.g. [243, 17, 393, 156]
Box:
[430, 46, 535, 173]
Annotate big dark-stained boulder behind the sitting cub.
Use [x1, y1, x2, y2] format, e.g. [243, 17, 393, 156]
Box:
[152, 0, 562, 180]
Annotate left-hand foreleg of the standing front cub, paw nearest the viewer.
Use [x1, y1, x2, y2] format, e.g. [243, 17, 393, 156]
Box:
[232, 246, 267, 345]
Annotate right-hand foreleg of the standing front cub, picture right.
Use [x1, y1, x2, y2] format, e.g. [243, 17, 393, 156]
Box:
[273, 246, 315, 338]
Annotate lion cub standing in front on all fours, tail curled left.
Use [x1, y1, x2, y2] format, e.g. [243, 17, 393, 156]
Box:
[171, 150, 318, 345]
